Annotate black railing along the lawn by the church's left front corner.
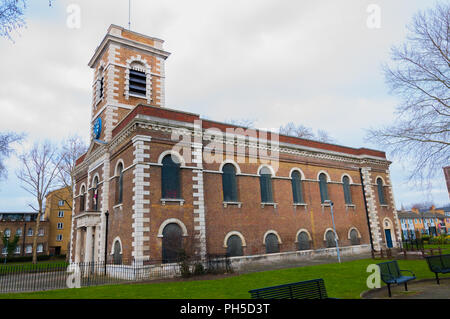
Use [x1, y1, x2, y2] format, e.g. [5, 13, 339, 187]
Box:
[0, 255, 232, 293]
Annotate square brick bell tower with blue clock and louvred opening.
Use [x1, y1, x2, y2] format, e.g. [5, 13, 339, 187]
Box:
[88, 25, 170, 143]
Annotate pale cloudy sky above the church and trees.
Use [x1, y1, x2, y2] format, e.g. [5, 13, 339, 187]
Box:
[0, 0, 449, 211]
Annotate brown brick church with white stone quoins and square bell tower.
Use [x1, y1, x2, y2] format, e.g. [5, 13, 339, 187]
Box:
[70, 25, 401, 264]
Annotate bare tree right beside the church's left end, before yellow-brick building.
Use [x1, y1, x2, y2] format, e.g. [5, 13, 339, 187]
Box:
[55, 135, 87, 209]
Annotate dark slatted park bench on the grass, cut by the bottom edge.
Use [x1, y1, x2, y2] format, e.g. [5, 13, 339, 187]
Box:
[249, 279, 328, 299]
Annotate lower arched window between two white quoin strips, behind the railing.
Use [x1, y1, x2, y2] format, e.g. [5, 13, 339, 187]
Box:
[162, 223, 183, 263]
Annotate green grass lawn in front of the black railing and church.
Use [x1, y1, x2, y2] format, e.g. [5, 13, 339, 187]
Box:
[0, 259, 434, 299]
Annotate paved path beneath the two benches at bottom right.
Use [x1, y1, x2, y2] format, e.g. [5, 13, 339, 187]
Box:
[362, 278, 450, 299]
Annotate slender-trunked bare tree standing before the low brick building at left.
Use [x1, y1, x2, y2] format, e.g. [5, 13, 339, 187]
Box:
[17, 141, 61, 264]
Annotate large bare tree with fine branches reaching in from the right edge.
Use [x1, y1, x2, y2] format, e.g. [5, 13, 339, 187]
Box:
[366, 3, 450, 187]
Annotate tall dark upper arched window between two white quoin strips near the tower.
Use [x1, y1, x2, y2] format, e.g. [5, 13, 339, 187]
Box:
[161, 154, 181, 198]
